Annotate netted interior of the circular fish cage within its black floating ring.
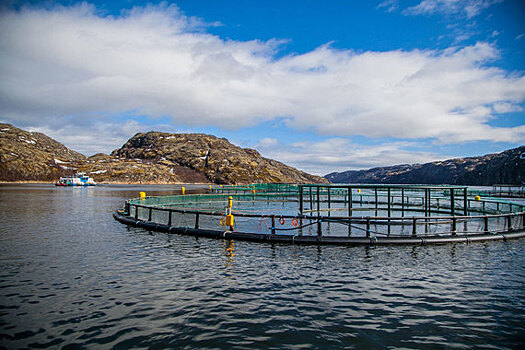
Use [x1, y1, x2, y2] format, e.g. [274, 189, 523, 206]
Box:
[124, 184, 525, 237]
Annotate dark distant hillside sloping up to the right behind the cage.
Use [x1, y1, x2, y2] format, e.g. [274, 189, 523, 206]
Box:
[325, 146, 525, 186]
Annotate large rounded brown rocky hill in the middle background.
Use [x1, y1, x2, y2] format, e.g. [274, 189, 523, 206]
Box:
[111, 132, 326, 184]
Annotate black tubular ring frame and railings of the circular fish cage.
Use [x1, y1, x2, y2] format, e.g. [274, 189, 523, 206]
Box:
[113, 184, 525, 245]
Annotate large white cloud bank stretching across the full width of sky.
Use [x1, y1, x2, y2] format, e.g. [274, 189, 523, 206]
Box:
[0, 1, 525, 149]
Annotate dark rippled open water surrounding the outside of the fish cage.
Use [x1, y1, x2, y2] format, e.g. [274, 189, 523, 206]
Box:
[0, 185, 525, 349]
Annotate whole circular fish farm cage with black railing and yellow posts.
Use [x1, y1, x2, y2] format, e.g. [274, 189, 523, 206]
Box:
[114, 184, 525, 245]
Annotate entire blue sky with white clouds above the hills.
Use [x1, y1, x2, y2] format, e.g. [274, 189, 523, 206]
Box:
[0, 0, 525, 175]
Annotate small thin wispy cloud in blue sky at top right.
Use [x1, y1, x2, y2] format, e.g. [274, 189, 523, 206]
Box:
[403, 0, 503, 18]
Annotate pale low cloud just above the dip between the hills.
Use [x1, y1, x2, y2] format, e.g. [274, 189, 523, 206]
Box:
[257, 138, 442, 175]
